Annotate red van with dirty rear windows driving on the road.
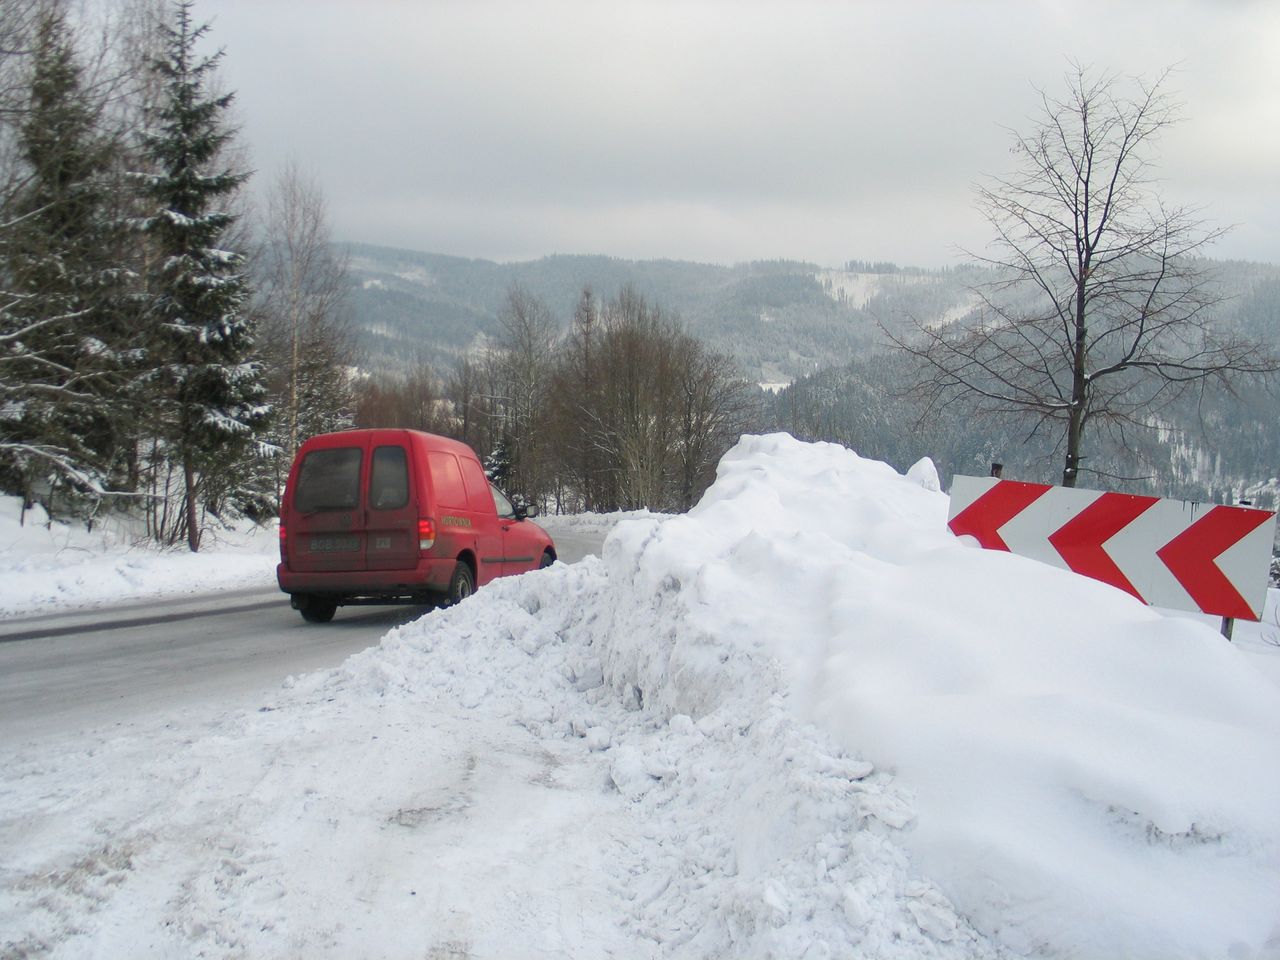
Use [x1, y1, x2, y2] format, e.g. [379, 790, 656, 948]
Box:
[275, 430, 556, 623]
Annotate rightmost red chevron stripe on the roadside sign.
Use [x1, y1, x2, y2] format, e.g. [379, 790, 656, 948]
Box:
[1156, 507, 1274, 620]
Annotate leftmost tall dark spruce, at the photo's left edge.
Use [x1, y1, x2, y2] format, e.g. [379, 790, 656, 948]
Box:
[0, 5, 129, 519]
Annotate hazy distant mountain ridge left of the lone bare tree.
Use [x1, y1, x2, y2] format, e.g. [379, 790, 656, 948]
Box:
[343, 243, 977, 384]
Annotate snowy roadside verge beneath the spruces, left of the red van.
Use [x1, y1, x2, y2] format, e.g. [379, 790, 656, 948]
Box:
[0, 497, 279, 617]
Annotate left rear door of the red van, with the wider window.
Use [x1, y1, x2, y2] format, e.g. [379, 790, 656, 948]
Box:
[287, 435, 369, 572]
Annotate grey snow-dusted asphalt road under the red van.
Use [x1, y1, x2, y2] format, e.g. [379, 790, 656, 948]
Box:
[0, 534, 603, 742]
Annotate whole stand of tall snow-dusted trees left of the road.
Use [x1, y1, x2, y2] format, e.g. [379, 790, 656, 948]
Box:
[0, 0, 351, 550]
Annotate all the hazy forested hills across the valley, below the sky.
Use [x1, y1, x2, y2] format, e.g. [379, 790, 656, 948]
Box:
[349, 244, 1280, 506]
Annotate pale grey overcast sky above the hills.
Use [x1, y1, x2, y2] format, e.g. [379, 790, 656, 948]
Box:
[204, 0, 1280, 266]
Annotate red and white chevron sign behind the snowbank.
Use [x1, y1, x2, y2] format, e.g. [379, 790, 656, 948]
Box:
[948, 476, 1276, 620]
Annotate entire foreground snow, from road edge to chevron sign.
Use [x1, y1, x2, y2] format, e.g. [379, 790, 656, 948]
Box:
[0, 435, 1280, 960]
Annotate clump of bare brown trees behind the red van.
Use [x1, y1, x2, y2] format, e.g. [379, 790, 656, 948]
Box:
[356, 287, 759, 512]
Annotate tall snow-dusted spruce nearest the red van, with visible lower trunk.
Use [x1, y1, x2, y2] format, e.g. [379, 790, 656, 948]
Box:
[137, 0, 270, 550]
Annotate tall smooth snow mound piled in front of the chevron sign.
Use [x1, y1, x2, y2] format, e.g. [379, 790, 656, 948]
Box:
[599, 436, 1280, 957]
